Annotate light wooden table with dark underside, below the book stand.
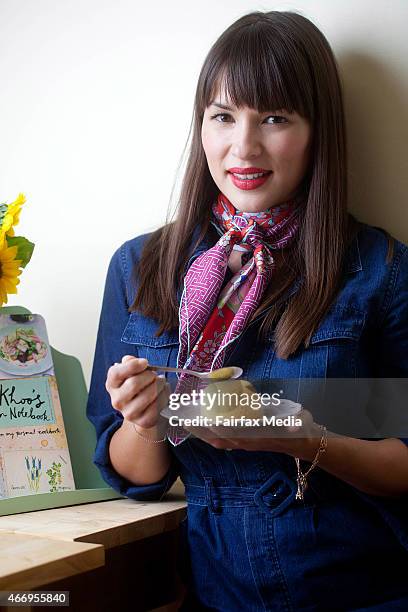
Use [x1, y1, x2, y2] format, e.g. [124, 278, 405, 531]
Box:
[0, 480, 186, 612]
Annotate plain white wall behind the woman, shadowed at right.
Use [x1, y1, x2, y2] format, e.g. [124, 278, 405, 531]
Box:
[0, 0, 408, 383]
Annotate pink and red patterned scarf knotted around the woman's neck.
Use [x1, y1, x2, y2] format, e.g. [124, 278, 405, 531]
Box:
[167, 193, 303, 446]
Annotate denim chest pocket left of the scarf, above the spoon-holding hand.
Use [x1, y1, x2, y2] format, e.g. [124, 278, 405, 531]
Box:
[121, 312, 179, 366]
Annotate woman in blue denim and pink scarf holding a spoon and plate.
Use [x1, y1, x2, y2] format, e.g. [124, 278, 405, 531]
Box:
[88, 12, 408, 611]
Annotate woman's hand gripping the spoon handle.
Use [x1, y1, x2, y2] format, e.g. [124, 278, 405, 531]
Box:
[105, 355, 170, 429]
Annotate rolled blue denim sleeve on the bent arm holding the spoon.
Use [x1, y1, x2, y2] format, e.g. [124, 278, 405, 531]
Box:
[87, 243, 178, 501]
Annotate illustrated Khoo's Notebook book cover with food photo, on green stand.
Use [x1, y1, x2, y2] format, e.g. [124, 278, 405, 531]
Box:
[0, 314, 75, 499]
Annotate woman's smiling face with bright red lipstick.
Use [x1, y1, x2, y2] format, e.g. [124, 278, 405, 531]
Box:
[201, 86, 311, 212]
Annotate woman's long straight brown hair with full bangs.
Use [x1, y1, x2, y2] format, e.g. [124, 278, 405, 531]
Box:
[129, 11, 366, 359]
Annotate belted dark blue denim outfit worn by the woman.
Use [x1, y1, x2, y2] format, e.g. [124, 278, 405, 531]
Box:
[87, 224, 408, 612]
